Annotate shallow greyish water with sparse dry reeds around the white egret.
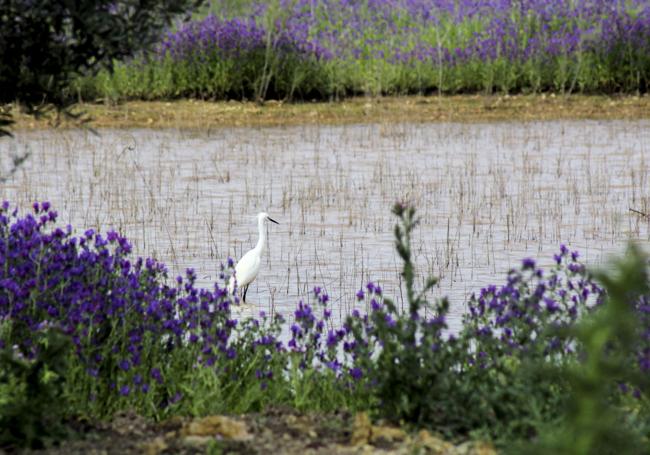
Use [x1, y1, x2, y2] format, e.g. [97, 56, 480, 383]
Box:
[0, 121, 650, 326]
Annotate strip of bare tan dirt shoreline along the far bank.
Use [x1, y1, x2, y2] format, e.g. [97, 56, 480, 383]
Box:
[8, 94, 650, 131]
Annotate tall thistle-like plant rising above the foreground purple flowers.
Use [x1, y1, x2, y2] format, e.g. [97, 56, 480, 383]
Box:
[346, 203, 455, 425]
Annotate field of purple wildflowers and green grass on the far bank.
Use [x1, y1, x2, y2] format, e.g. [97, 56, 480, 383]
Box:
[78, 0, 650, 101]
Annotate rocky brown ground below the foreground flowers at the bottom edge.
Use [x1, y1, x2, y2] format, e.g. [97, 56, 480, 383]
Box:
[17, 409, 496, 455]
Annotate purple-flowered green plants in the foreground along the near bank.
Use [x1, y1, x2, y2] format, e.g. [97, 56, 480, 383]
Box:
[0, 202, 650, 453]
